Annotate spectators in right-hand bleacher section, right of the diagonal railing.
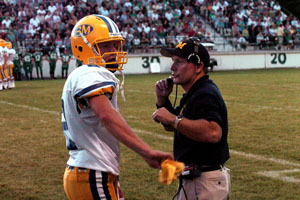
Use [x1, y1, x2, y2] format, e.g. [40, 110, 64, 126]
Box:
[196, 0, 300, 50]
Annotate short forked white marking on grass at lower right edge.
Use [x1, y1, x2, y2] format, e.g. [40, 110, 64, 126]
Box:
[256, 169, 300, 183]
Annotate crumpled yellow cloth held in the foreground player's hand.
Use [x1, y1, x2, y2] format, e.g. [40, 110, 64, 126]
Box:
[158, 160, 184, 185]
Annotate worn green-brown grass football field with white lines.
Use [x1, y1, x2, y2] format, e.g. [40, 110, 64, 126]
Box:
[0, 69, 300, 200]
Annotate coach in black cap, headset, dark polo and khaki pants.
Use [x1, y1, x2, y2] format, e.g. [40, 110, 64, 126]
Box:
[152, 37, 230, 200]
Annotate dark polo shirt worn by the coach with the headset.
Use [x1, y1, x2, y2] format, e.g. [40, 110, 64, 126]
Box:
[162, 75, 229, 165]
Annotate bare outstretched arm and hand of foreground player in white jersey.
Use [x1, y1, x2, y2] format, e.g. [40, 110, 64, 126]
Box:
[89, 95, 173, 168]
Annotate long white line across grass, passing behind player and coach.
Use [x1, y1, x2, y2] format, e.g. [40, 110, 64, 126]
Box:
[0, 100, 300, 167]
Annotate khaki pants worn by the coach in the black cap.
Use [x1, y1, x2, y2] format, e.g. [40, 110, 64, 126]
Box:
[177, 167, 231, 200]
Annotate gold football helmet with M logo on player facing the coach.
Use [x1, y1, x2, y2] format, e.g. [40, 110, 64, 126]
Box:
[71, 15, 128, 70]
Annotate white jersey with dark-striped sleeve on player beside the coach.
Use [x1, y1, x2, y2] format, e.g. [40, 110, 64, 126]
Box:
[62, 65, 120, 175]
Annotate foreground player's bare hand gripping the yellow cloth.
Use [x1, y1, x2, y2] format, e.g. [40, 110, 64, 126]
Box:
[143, 150, 174, 169]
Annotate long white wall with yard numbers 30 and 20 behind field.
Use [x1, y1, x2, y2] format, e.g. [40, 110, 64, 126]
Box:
[33, 51, 300, 78]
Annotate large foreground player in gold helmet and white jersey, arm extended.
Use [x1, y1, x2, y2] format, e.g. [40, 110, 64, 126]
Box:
[62, 15, 173, 200]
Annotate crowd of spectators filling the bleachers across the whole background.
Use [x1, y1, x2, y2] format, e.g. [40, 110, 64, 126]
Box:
[0, 0, 300, 53]
